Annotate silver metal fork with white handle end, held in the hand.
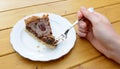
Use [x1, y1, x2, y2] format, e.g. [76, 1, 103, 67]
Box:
[56, 8, 94, 44]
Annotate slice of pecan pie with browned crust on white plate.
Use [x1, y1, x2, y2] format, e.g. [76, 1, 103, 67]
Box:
[25, 15, 57, 48]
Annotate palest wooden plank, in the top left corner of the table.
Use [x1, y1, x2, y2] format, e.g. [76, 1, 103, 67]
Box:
[0, 0, 62, 11]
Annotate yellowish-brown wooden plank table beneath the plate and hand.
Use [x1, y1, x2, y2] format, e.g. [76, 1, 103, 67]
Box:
[0, 0, 120, 69]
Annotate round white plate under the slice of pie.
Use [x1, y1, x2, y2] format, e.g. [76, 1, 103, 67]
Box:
[10, 13, 76, 61]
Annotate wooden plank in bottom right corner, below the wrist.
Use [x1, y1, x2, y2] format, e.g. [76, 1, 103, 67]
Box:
[70, 56, 120, 69]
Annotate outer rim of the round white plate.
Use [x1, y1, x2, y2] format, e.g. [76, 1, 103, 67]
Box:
[10, 12, 76, 61]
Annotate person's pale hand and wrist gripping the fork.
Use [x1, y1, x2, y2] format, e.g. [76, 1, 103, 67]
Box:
[77, 7, 120, 64]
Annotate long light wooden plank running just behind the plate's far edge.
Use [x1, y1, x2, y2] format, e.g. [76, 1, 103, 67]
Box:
[0, 0, 120, 29]
